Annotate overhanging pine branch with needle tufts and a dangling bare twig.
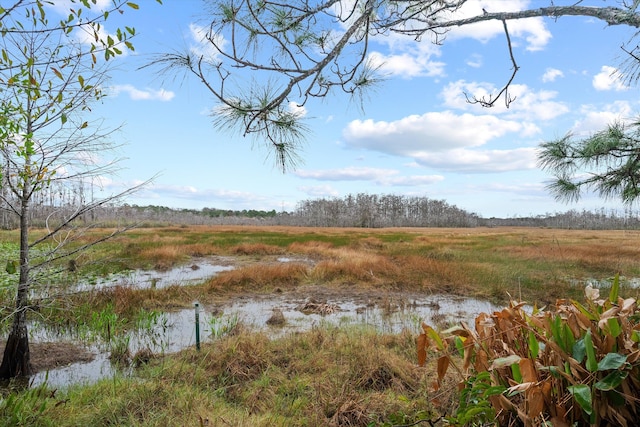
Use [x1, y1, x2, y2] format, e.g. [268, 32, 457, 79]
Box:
[152, 0, 640, 170]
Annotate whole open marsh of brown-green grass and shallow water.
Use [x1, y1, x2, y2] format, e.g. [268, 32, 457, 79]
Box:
[0, 226, 640, 426]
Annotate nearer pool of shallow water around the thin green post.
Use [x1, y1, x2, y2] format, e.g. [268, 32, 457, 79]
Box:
[32, 293, 500, 388]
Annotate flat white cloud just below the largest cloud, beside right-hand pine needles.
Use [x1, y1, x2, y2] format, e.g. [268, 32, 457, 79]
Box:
[415, 148, 536, 173]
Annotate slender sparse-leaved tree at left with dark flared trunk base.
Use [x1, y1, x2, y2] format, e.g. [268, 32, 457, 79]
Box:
[0, 0, 156, 378]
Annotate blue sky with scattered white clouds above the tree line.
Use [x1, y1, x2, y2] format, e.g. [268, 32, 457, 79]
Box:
[57, 0, 639, 217]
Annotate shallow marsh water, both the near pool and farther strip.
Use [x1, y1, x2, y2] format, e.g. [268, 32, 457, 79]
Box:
[26, 258, 500, 388]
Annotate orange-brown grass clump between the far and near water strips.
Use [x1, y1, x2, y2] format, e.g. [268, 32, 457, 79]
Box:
[207, 262, 307, 290]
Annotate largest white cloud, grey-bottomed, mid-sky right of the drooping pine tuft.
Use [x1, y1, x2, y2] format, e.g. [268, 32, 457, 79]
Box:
[343, 111, 524, 157]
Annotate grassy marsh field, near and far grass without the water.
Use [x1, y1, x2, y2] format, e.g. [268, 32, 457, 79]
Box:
[0, 226, 640, 426]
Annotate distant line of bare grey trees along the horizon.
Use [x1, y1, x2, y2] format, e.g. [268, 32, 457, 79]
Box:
[0, 186, 640, 230]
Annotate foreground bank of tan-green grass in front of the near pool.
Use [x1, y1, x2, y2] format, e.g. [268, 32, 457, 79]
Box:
[34, 328, 429, 426]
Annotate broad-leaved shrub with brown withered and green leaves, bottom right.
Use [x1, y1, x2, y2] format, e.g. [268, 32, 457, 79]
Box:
[418, 277, 640, 426]
